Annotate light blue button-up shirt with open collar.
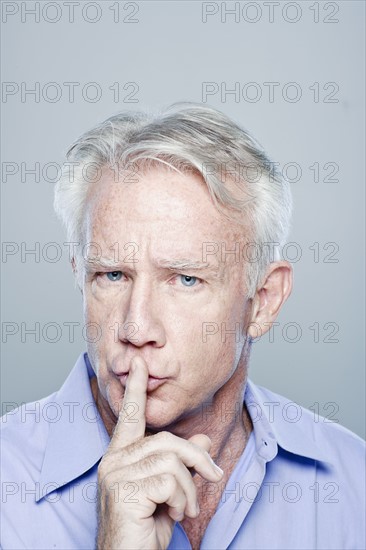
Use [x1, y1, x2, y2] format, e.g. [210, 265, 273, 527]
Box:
[0, 354, 366, 550]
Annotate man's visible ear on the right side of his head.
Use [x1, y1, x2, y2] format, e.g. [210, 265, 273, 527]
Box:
[248, 261, 292, 339]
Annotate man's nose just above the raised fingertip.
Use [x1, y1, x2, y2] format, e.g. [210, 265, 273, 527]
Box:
[120, 275, 166, 348]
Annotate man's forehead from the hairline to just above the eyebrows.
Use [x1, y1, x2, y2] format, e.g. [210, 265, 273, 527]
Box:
[85, 167, 243, 247]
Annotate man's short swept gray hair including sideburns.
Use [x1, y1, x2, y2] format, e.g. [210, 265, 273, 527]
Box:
[54, 103, 292, 297]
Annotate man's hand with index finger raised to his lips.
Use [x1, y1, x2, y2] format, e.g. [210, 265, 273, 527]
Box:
[97, 357, 222, 550]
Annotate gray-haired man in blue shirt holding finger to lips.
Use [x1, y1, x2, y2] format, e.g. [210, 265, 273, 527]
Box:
[1, 104, 365, 550]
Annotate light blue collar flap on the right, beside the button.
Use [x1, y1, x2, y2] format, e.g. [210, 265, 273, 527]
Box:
[244, 380, 332, 464]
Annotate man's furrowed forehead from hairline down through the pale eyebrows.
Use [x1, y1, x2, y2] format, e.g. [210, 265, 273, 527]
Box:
[77, 169, 253, 277]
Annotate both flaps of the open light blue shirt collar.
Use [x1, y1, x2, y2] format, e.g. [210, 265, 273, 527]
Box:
[37, 353, 331, 501]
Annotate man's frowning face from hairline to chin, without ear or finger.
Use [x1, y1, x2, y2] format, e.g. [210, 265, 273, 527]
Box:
[83, 168, 251, 429]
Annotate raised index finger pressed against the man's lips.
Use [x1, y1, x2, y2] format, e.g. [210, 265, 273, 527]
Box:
[110, 357, 149, 449]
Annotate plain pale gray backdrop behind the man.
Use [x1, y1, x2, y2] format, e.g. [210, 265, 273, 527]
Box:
[1, 1, 365, 437]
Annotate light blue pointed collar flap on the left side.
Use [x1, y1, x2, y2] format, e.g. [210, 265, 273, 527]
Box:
[37, 353, 110, 500]
